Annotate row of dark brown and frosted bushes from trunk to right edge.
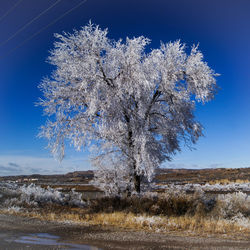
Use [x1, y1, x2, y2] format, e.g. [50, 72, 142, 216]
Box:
[91, 190, 250, 219]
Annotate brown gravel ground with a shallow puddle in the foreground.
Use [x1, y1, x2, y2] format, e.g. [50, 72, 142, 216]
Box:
[0, 214, 250, 250]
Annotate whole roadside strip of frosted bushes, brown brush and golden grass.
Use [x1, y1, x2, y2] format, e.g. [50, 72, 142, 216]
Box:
[0, 183, 250, 232]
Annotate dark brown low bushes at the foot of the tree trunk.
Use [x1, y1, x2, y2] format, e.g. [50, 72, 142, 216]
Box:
[89, 193, 216, 216]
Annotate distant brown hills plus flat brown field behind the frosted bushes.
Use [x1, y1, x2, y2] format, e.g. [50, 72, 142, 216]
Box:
[0, 168, 250, 192]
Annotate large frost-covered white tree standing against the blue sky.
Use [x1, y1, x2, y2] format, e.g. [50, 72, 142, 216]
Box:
[40, 23, 216, 192]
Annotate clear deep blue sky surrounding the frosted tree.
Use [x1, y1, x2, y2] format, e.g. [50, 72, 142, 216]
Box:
[0, 0, 250, 175]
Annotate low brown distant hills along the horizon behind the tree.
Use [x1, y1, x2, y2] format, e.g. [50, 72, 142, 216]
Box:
[0, 168, 250, 184]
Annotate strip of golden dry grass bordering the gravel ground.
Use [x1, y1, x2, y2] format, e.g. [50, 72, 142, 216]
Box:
[1, 209, 250, 238]
